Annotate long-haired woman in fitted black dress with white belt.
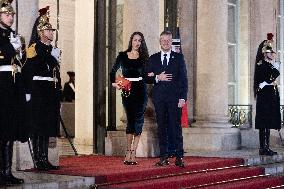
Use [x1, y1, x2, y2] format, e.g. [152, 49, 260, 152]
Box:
[110, 32, 149, 165]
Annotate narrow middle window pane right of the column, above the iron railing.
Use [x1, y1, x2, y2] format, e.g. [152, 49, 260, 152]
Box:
[228, 45, 236, 82]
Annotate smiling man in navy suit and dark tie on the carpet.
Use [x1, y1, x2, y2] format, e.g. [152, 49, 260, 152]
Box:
[146, 31, 188, 167]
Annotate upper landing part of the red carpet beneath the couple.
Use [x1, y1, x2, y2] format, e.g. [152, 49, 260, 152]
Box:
[49, 155, 243, 183]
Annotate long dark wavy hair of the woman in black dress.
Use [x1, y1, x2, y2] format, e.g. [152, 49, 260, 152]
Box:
[126, 32, 149, 64]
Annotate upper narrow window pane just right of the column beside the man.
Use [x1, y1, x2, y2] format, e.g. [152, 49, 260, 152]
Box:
[228, 5, 236, 43]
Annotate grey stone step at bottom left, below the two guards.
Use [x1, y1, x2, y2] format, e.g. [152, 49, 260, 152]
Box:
[6, 171, 95, 189]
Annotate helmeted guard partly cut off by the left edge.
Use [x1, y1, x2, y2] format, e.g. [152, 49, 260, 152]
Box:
[0, 0, 27, 186]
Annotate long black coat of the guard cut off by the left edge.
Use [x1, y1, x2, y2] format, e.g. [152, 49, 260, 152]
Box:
[0, 28, 28, 142]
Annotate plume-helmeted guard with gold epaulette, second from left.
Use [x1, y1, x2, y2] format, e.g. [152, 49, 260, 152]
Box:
[23, 8, 61, 170]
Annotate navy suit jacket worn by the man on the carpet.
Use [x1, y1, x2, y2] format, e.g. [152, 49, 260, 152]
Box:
[146, 51, 188, 102]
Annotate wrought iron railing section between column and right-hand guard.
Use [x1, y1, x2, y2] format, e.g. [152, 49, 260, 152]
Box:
[229, 104, 253, 127]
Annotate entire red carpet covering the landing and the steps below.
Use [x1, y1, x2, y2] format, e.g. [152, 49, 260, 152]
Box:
[35, 155, 284, 189]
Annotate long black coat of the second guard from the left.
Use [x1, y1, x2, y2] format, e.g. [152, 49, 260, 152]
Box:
[23, 41, 61, 137]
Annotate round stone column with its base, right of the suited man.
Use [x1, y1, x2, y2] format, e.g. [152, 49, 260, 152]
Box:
[190, 0, 240, 150]
